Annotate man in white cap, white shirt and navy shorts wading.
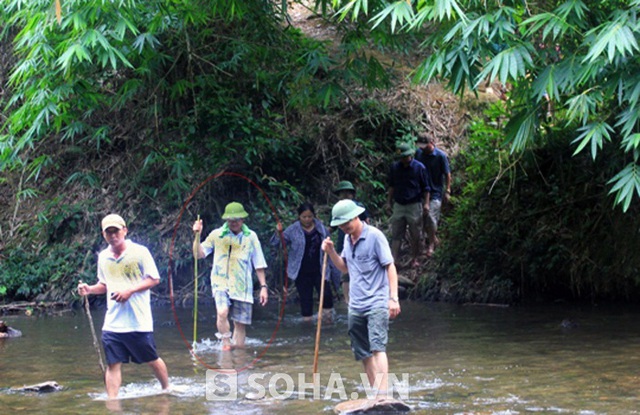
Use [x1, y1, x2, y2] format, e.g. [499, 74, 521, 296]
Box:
[78, 214, 169, 399]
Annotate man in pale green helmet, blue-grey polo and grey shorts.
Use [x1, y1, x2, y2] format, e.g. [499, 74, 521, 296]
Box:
[322, 199, 400, 397]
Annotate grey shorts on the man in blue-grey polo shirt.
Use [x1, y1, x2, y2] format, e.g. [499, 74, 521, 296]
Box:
[349, 308, 389, 360]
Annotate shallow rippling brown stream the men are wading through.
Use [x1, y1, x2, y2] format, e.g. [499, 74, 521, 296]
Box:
[0, 302, 640, 414]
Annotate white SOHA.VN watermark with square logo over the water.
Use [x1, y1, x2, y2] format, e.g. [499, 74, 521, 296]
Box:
[206, 370, 409, 401]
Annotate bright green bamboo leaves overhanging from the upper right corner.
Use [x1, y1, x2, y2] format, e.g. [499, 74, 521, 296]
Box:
[328, 0, 640, 211]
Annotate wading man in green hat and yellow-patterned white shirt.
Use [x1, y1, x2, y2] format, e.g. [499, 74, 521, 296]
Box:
[193, 202, 269, 350]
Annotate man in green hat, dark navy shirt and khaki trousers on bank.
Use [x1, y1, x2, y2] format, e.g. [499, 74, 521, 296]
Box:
[387, 143, 431, 267]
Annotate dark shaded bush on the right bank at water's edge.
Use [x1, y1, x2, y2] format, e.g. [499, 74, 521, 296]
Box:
[422, 104, 640, 303]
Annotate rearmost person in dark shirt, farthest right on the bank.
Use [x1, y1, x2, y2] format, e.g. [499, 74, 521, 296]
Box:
[416, 132, 451, 257]
